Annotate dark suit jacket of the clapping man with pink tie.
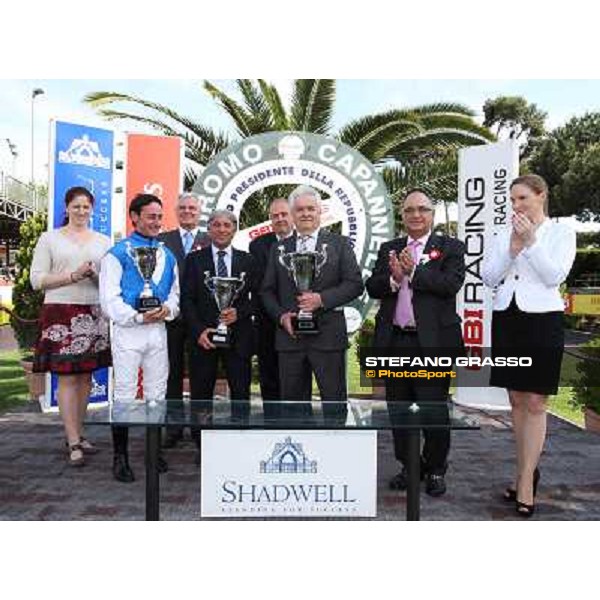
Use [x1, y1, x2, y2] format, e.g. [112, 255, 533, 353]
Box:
[366, 234, 465, 348]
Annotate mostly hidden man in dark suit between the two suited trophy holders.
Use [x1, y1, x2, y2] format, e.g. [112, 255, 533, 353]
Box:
[248, 198, 293, 408]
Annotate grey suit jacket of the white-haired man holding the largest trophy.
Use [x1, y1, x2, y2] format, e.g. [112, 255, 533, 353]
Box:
[261, 230, 364, 352]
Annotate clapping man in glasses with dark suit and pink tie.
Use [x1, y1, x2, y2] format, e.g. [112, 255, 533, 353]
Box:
[366, 190, 465, 496]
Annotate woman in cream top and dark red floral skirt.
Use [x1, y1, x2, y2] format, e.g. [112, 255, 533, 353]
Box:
[30, 187, 111, 466]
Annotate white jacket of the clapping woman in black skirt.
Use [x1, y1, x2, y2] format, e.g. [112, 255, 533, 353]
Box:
[481, 219, 577, 313]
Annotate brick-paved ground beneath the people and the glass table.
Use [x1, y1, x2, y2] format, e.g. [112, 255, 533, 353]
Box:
[0, 404, 600, 520]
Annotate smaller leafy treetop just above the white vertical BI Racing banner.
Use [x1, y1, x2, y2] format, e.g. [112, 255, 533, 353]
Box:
[483, 96, 548, 158]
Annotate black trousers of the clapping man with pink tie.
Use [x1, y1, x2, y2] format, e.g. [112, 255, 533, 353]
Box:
[386, 327, 450, 475]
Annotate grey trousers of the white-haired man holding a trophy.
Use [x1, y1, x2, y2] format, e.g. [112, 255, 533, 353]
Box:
[279, 350, 348, 424]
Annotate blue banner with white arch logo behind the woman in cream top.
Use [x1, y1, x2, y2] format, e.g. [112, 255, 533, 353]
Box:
[44, 120, 114, 410]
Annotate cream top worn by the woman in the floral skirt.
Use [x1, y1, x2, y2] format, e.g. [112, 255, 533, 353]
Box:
[29, 229, 111, 304]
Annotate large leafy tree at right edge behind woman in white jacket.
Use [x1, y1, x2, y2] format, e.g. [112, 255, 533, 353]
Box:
[527, 113, 600, 221]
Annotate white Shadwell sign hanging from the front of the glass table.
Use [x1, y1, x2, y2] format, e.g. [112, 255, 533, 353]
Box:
[201, 431, 377, 518]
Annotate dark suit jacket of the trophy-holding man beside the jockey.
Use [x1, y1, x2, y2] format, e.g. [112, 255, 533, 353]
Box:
[181, 246, 256, 356]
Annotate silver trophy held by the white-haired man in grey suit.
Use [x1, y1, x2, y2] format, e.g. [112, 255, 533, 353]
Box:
[279, 244, 327, 334]
